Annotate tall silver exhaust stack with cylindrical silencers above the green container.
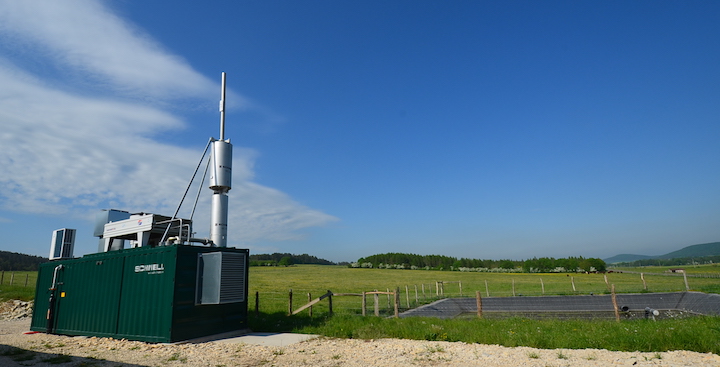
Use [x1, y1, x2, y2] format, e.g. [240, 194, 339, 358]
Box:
[210, 72, 232, 247]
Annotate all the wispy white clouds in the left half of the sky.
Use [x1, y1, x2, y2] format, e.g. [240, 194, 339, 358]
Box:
[0, 0, 336, 247]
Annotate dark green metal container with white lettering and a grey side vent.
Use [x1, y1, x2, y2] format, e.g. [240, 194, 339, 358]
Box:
[30, 245, 248, 342]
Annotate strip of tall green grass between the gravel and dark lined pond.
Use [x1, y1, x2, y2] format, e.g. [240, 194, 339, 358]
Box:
[295, 315, 720, 354]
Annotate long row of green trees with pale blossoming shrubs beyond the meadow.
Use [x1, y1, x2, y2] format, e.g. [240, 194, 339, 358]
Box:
[349, 252, 607, 273]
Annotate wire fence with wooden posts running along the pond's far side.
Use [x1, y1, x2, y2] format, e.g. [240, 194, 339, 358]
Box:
[248, 273, 720, 316]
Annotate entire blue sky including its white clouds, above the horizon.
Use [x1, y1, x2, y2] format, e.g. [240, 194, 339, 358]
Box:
[0, 0, 720, 261]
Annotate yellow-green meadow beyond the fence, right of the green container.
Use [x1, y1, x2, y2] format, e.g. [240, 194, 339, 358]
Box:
[250, 265, 720, 314]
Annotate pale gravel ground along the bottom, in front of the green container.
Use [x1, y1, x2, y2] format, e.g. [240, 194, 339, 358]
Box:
[0, 304, 720, 367]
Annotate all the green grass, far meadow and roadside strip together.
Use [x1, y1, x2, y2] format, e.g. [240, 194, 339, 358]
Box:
[5, 265, 720, 354]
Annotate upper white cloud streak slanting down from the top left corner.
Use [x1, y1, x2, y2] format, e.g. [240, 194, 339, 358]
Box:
[0, 0, 216, 102]
